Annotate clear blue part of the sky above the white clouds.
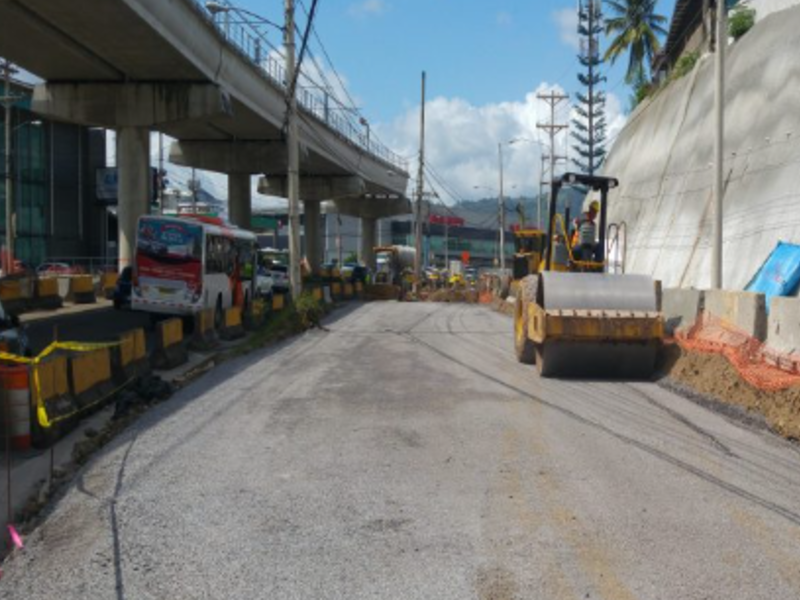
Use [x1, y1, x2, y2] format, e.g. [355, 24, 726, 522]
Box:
[238, 0, 675, 122]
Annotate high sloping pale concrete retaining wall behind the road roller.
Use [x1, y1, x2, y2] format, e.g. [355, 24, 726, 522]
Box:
[603, 7, 800, 289]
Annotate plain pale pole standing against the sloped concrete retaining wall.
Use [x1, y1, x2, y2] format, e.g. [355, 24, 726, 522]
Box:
[711, 0, 728, 289]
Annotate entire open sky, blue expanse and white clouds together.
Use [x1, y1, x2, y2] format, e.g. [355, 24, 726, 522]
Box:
[230, 0, 675, 204]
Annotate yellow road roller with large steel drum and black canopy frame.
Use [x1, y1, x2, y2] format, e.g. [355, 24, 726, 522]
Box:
[514, 173, 664, 378]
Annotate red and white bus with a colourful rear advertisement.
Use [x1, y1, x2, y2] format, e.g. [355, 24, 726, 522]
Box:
[131, 215, 258, 324]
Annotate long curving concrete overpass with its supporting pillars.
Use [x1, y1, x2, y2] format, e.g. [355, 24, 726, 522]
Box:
[0, 0, 408, 265]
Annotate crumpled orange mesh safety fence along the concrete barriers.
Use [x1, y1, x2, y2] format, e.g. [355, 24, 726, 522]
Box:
[675, 312, 800, 392]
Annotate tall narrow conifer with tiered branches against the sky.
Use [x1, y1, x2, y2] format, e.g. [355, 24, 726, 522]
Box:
[572, 0, 606, 175]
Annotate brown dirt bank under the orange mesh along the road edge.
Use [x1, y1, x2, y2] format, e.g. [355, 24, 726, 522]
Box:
[659, 343, 800, 440]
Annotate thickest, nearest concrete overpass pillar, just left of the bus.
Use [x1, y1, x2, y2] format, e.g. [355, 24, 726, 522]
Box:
[117, 127, 150, 270]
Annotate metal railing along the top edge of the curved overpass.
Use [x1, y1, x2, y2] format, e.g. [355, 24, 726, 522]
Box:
[191, 0, 408, 172]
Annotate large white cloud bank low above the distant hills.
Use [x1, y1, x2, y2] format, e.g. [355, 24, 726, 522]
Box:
[375, 83, 626, 203]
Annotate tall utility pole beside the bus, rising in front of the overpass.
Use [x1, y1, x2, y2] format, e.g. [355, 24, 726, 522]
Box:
[283, 0, 303, 300]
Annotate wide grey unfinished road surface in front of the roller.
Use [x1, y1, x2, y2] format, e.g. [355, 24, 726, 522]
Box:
[0, 303, 800, 600]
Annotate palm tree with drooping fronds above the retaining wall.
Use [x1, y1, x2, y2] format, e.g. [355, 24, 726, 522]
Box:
[605, 0, 667, 84]
